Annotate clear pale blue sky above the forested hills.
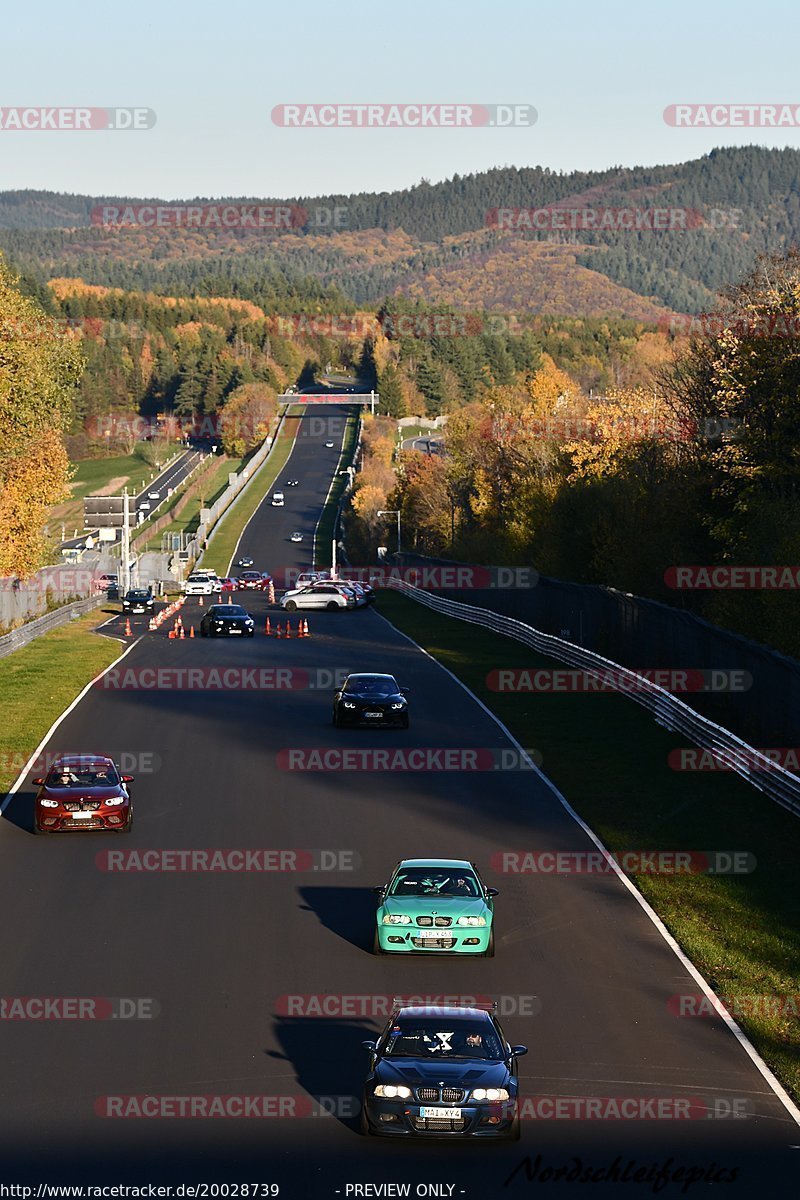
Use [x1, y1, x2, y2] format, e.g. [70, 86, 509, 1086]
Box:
[0, 0, 800, 199]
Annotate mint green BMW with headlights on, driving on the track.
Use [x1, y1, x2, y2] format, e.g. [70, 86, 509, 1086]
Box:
[372, 858, 498, 959]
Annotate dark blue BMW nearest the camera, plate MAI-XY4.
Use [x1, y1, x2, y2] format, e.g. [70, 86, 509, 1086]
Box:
[361, 1003, 528, 1141]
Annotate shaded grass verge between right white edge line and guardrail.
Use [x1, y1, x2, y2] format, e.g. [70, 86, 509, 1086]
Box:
[378, 592, 800, 1100]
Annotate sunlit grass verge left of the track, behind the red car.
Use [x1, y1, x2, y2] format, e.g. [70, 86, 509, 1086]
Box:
[0, 604, 121, 793]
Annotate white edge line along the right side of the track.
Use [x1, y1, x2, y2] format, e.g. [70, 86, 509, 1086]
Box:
[377, 612, 800, 1126]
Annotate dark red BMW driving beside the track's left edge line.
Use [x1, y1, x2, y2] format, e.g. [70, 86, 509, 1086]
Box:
[34, 754, 133, 834]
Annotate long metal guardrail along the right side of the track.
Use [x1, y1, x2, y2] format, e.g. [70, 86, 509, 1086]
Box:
[384, 576, 800, 816]
